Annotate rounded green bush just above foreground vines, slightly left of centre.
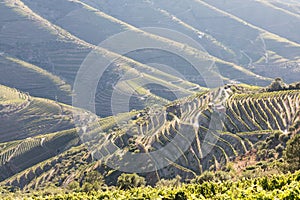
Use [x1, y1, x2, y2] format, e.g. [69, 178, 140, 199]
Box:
[117, 174, 146, 190]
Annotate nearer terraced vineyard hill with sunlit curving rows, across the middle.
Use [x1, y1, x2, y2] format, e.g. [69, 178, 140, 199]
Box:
[2, 85, 300, 189]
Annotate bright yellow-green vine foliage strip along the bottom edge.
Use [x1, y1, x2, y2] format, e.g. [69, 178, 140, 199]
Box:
[2, 171, 300, 200]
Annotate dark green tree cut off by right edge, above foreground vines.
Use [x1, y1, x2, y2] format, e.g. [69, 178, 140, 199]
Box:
[285, 134, 300, 171]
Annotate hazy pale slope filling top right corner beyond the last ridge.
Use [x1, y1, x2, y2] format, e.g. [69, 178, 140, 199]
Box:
[205, 0, 300, 44]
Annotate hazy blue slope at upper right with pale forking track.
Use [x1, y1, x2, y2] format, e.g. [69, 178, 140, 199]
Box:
[154, 0, 300, 82]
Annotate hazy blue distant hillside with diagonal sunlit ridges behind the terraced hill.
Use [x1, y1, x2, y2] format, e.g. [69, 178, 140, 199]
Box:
[0, 0, 299, 116]
